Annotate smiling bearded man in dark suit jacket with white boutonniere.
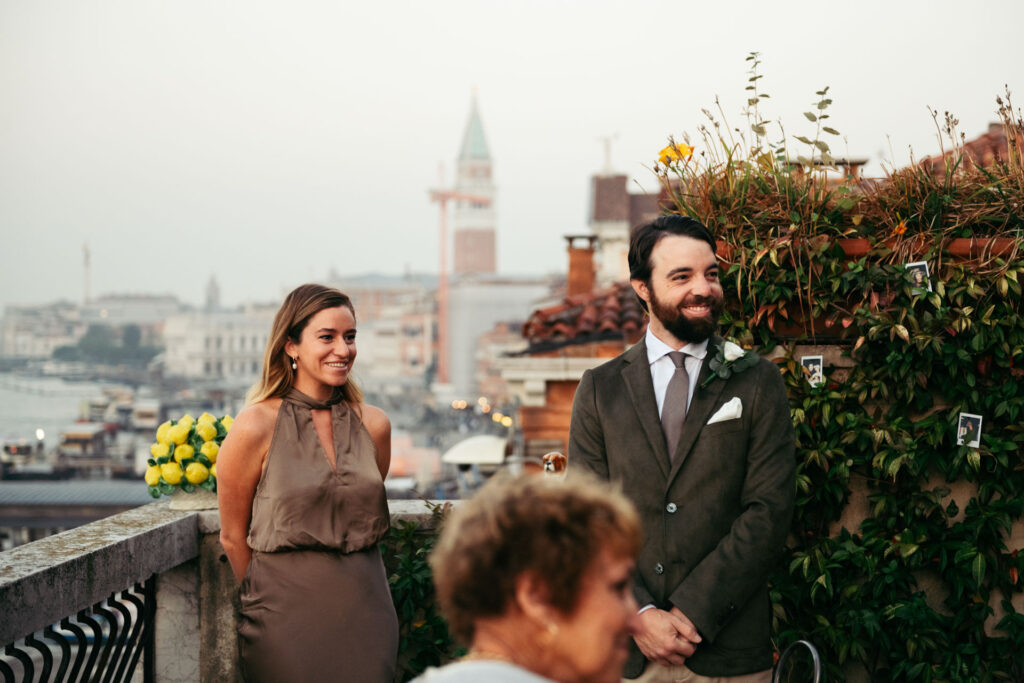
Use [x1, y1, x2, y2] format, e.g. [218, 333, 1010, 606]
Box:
[569, 216, 796, 683]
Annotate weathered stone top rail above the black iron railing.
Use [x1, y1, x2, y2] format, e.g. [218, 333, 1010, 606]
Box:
[0, 501, 200, 644]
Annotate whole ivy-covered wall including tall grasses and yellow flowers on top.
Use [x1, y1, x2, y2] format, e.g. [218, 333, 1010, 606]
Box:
[655, 62, 1024, 681]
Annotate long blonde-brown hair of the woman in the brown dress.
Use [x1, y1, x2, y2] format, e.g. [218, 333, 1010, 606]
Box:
[246, 285, 362, 405]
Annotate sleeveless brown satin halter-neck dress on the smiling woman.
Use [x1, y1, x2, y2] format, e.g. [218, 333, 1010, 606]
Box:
[239, 389, 398, 683]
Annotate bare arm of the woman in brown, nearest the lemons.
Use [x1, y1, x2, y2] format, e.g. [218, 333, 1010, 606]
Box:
[217, 399, 281, 583]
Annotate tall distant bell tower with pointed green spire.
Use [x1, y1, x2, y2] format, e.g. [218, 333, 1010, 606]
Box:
[452, 96, 498, 276]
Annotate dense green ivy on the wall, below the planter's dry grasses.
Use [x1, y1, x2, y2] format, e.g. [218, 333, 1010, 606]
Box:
[712, 240, 1024, 681]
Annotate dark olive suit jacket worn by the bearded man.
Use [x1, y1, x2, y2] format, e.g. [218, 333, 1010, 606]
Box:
[568, 336, 796, 678]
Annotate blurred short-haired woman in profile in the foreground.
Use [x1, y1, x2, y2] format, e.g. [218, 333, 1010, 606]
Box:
[416, 475, 640, 683]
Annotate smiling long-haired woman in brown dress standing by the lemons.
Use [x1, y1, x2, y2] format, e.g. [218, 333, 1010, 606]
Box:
[217, 285, 398, 683]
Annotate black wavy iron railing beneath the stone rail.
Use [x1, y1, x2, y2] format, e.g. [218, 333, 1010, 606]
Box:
[0, 575, 157, 683]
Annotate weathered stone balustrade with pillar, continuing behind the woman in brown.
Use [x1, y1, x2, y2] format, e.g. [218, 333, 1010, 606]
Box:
[0, 500, 444, 683]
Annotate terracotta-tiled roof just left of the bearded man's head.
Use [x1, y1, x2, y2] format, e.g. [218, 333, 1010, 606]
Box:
[522, 283, 646, 352]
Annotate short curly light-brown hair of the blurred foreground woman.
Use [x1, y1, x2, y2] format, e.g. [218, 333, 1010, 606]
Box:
[430, 475, 641, 643]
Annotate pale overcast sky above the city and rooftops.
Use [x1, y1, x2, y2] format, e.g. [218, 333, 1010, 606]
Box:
[0, 0, 1024, 313]
